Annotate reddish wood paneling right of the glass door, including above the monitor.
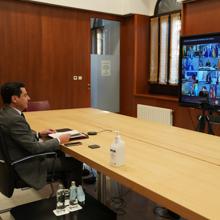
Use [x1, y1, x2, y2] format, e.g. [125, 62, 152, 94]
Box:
[121, 0, 220, 133]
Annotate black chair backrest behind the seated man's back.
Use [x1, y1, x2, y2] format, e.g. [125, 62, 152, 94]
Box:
[0, 126, 16, 198]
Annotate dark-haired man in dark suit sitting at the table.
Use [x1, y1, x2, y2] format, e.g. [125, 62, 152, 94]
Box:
[0, 82, 82, 189]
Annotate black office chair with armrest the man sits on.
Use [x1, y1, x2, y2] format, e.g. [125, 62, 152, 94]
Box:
[0, 125, 57, 198]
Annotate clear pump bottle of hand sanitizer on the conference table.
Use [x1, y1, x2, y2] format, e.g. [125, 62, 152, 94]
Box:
[110, 131, 125, 166]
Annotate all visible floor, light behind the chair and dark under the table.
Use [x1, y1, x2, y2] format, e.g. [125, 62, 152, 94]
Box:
[0, 178, 183, 220]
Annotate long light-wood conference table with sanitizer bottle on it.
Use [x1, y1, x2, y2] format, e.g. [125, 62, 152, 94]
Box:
[25, 108, 220, 220]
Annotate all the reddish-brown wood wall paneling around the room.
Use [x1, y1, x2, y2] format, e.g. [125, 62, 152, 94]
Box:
[0, 0, 220, 132]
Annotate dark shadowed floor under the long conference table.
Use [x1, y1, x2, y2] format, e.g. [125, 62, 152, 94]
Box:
[85, 181, 185, 220]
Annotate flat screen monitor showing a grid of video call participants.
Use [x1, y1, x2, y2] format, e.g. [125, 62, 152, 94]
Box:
[179, 33, 220, 109]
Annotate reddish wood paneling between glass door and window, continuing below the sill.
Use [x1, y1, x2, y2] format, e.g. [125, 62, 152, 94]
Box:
[120, 15, 199, 129]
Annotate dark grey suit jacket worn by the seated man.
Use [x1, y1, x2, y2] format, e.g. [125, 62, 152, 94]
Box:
[0, 106, 59, 189]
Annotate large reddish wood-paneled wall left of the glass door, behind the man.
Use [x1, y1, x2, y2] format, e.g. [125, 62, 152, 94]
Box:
[0, 0, 120, 109]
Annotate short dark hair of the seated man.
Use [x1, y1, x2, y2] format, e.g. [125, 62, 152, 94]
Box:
[1, 82, 25, 104]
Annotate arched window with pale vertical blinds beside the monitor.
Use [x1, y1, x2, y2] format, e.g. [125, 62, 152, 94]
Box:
[149, 0, 181, 93]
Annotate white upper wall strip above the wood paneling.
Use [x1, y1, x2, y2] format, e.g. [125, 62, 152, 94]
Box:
[25, 0, 156, 15]
